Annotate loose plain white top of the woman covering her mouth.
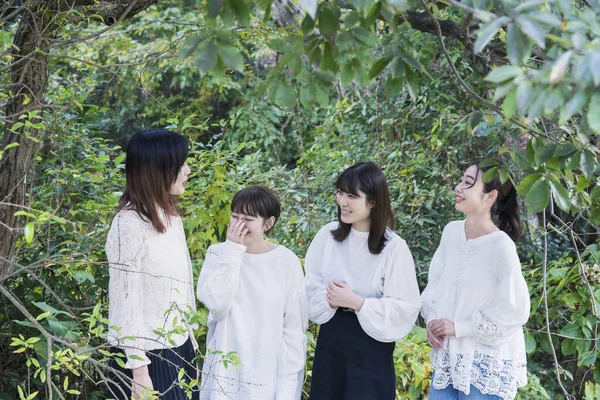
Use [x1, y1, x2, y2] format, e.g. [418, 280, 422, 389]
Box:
[197, 241, 308, 400]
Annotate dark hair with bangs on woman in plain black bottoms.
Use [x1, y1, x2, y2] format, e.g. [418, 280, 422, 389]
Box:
[331, 162, 396, 254]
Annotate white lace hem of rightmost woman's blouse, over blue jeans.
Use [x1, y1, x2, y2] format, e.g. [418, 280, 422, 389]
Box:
[432, 351, 527, 400]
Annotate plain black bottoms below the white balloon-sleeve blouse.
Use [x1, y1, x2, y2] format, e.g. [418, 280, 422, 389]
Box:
[310, 309, 396, 400]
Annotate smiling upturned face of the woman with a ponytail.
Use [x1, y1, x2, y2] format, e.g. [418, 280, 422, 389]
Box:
[454, 165, 498, 215]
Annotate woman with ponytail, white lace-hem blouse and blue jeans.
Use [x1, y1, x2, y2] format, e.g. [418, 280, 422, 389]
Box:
[421, 163, 529, 400]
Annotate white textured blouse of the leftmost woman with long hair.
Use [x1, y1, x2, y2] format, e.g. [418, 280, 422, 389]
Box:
[105, 209, 198, 368]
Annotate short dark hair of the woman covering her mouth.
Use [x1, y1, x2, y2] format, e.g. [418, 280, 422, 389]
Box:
[231, 185, 281, 229]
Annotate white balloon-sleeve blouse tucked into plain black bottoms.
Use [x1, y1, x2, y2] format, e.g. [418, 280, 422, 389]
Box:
[305, 222, 421, 342]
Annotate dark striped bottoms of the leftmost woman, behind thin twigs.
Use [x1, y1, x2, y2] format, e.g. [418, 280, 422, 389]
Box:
[106, 338, 200, 400]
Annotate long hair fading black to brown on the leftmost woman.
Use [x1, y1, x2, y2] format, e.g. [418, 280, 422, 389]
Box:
[118, 129, 188, 233]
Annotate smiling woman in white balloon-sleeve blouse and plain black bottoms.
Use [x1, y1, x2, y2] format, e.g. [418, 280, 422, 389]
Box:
[305, 162, 421, 400]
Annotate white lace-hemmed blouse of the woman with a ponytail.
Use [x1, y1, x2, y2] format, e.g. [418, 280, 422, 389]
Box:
[421, 221, 529, 400]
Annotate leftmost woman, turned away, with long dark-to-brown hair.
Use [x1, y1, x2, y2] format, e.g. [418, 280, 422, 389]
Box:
[106, 129, 198, 400]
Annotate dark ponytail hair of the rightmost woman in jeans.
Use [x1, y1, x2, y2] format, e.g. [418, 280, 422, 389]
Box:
[475, 160, 521, 241]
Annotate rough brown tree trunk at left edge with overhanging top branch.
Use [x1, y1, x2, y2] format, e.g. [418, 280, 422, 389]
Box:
[0, 0, 157, 281]
